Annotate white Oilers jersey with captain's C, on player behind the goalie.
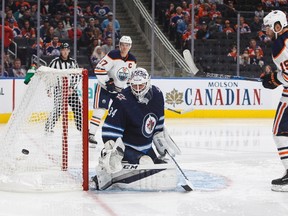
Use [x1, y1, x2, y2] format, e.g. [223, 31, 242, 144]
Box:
[94, 50, 136, 90]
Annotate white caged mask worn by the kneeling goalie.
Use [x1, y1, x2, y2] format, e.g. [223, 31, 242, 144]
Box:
[130, 67, 152, 104]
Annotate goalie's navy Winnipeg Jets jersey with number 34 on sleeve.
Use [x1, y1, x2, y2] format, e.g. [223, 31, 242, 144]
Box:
[102, 86, 164, 154]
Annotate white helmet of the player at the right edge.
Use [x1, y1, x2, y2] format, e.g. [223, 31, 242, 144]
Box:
[263, 10, 287, 34]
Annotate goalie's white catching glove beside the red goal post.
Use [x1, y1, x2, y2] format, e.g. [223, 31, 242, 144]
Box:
[99, 138, 125, 173]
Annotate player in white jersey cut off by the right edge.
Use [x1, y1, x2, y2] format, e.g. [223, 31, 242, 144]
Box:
[262, 10, 288, 191]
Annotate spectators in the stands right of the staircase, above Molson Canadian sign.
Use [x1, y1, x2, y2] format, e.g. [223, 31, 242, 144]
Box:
[157, 0, 288, 76]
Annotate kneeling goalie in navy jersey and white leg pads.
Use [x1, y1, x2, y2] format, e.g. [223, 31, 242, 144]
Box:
[94, 68, 180, 190]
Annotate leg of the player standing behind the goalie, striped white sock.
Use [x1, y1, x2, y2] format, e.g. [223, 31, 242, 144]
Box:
[89, 85, 111, 144]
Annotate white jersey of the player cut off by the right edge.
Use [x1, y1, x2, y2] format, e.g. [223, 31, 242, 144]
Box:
[272, 31, 288, 102]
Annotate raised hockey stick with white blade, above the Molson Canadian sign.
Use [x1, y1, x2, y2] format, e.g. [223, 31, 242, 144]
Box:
[183, 49, 262, 82]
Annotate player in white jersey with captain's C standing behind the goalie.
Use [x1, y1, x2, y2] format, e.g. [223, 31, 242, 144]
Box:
[89, 36, 136, 144]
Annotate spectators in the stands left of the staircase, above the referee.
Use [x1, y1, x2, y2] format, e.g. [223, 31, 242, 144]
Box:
[0, 0, 121, 77]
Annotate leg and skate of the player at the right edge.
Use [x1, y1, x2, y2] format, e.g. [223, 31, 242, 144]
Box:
[271, 102, 288, 191]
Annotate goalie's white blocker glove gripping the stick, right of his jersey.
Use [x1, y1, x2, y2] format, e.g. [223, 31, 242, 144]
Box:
[153, 127, 181, 157]
